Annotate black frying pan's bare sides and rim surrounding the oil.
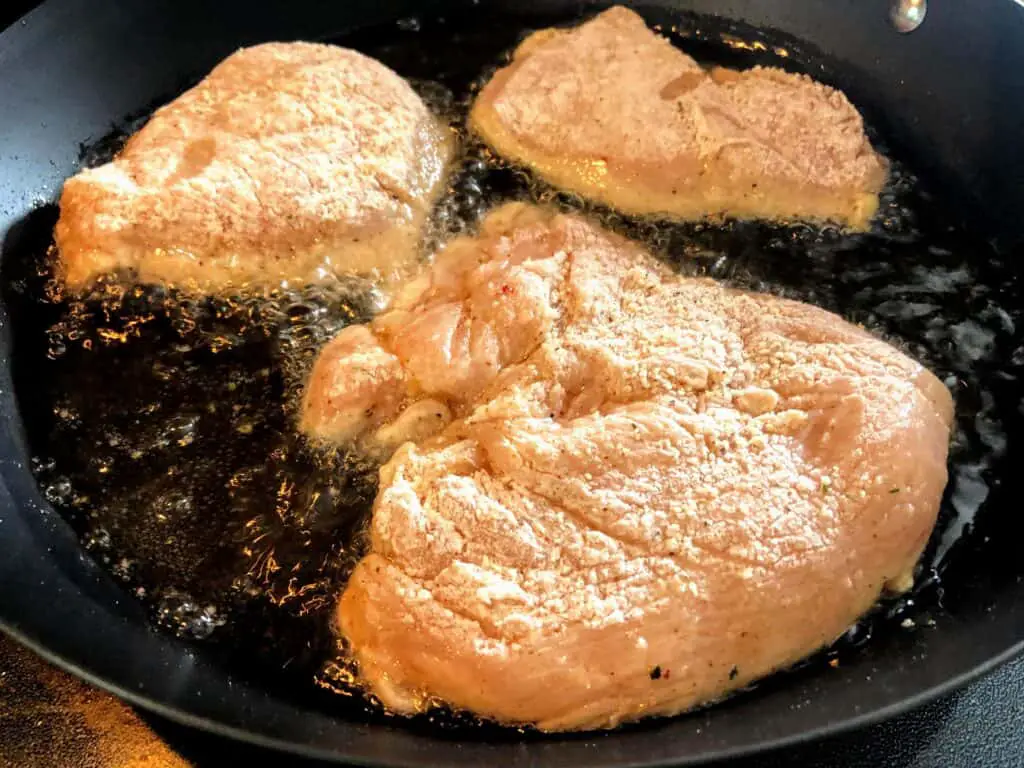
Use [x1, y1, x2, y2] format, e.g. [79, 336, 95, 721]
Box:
[0, 0, 1024, 766]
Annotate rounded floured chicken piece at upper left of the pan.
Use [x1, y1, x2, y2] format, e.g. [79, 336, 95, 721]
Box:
[56, 43, 452, 292]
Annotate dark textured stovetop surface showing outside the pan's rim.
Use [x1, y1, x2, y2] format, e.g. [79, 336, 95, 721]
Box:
[0, 0, 1024, 768]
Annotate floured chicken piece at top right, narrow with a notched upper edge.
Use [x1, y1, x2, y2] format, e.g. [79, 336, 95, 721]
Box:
[470, 7, 887, 228]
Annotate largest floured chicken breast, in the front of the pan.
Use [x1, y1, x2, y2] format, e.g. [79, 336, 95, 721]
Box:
[303, 204, 952, 730]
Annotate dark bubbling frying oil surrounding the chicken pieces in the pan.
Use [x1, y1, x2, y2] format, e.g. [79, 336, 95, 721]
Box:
[5, 10, 1024, 727]
